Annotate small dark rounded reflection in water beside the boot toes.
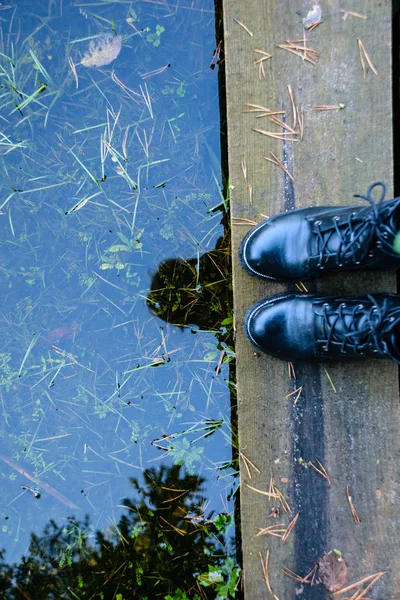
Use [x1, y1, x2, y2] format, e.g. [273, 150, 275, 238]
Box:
[148, 219, 232, 342]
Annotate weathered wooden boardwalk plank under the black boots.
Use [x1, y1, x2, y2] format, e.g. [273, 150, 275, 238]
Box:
[224, 0, 400, 600]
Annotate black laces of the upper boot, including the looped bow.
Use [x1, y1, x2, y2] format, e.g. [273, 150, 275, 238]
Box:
[315, 181, 400, 269]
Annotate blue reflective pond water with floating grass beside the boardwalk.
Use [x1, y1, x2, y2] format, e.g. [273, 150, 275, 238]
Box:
[0, 0, 238, 600]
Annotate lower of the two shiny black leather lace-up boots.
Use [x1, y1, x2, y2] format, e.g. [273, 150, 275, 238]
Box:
[244, 294, 400, 364]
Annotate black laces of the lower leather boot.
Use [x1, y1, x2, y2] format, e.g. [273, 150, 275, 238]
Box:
[322, 296, 400, 364]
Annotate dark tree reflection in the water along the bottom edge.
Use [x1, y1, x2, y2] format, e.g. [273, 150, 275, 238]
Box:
[0, 466, 238, 600]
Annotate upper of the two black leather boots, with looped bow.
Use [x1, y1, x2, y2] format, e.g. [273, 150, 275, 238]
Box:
[240, 182, 400, 281]
